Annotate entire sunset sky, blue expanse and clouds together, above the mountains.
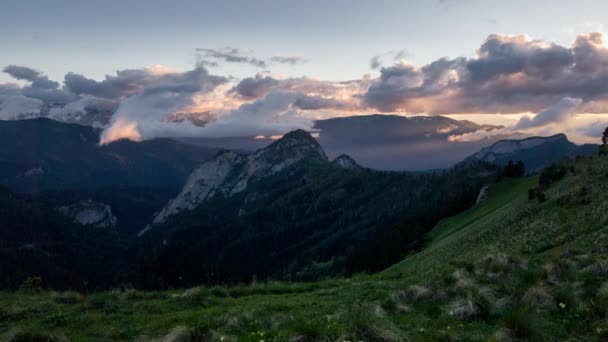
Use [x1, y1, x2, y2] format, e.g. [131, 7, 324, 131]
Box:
[0, 0, 608, 142]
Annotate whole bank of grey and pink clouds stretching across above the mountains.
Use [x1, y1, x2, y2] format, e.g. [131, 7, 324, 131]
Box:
[0, 32, 608, 142]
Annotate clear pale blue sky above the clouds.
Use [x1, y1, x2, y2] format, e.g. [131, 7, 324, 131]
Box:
[0, 0, 608, 82]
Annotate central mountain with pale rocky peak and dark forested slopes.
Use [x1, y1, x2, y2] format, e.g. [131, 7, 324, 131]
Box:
[134, 130, 495, 287]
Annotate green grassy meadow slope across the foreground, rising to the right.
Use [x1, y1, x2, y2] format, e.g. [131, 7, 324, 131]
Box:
[0, 156, 608, 341]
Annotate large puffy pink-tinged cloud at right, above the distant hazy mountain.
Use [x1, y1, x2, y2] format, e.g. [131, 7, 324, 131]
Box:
[363, 32, 608, 114]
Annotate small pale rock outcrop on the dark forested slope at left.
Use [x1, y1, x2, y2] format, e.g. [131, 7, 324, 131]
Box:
[58, 199, 116, 228]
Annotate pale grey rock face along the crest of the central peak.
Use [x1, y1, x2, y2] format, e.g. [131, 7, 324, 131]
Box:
[151, 130, 327, 226]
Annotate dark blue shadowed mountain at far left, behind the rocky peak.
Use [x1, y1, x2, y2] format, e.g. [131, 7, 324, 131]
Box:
[0, 118, 217, 235]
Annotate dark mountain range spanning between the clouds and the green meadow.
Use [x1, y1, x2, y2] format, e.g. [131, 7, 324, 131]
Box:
[0, 116, 597, 288]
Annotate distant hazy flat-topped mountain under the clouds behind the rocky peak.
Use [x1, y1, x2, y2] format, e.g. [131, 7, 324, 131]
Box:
[178, 114, 506, 171]
